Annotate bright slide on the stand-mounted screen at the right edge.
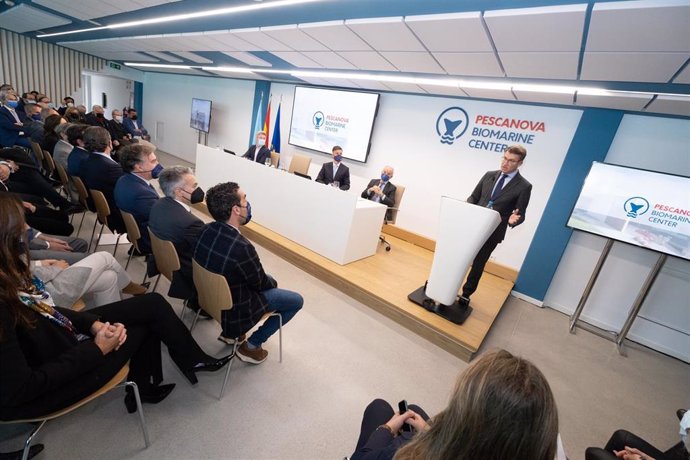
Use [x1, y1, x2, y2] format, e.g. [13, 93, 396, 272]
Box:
[568, 162, 690, 260]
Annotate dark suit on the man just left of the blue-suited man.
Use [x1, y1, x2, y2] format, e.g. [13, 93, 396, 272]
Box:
[80, 153, 125, 233]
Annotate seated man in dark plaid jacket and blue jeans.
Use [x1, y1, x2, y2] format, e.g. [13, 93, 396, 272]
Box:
[194, 182, 304, 364]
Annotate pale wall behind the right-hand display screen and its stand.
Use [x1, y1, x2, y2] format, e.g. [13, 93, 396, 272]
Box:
[544, 115, 690, 362]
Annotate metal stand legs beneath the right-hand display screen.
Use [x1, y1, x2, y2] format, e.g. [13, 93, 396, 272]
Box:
[570, 235, 668, 356]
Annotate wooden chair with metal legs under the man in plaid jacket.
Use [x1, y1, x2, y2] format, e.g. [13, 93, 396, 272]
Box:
[190, 260, 283, 399]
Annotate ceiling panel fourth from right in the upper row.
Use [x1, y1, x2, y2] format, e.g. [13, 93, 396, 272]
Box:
[345, 17, 424, 51]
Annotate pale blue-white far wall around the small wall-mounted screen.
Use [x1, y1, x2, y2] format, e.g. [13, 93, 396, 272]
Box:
[143, 72, 255, 162]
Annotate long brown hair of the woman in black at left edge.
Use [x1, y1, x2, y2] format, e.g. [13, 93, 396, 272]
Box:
[0, 193, 33, 340]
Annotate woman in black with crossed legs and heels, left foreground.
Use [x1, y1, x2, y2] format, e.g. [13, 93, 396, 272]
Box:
[0, 198, 231, 420]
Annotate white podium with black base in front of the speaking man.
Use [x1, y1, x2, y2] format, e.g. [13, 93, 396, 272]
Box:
[408, 196, 501, 324]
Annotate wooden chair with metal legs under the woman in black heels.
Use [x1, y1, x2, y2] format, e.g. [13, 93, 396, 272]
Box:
[0, 363, 150, 460]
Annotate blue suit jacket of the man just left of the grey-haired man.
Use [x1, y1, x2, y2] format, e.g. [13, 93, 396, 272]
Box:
[115, 174, 158, 253]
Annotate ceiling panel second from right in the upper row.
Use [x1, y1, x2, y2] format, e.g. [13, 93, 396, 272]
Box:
[484, 5, 587, 52]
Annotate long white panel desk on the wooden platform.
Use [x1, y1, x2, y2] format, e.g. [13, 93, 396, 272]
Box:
[196, 144, 386, 265]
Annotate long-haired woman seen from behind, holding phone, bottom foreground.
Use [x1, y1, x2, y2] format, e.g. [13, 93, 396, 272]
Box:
[351, 350, 558, 460]
